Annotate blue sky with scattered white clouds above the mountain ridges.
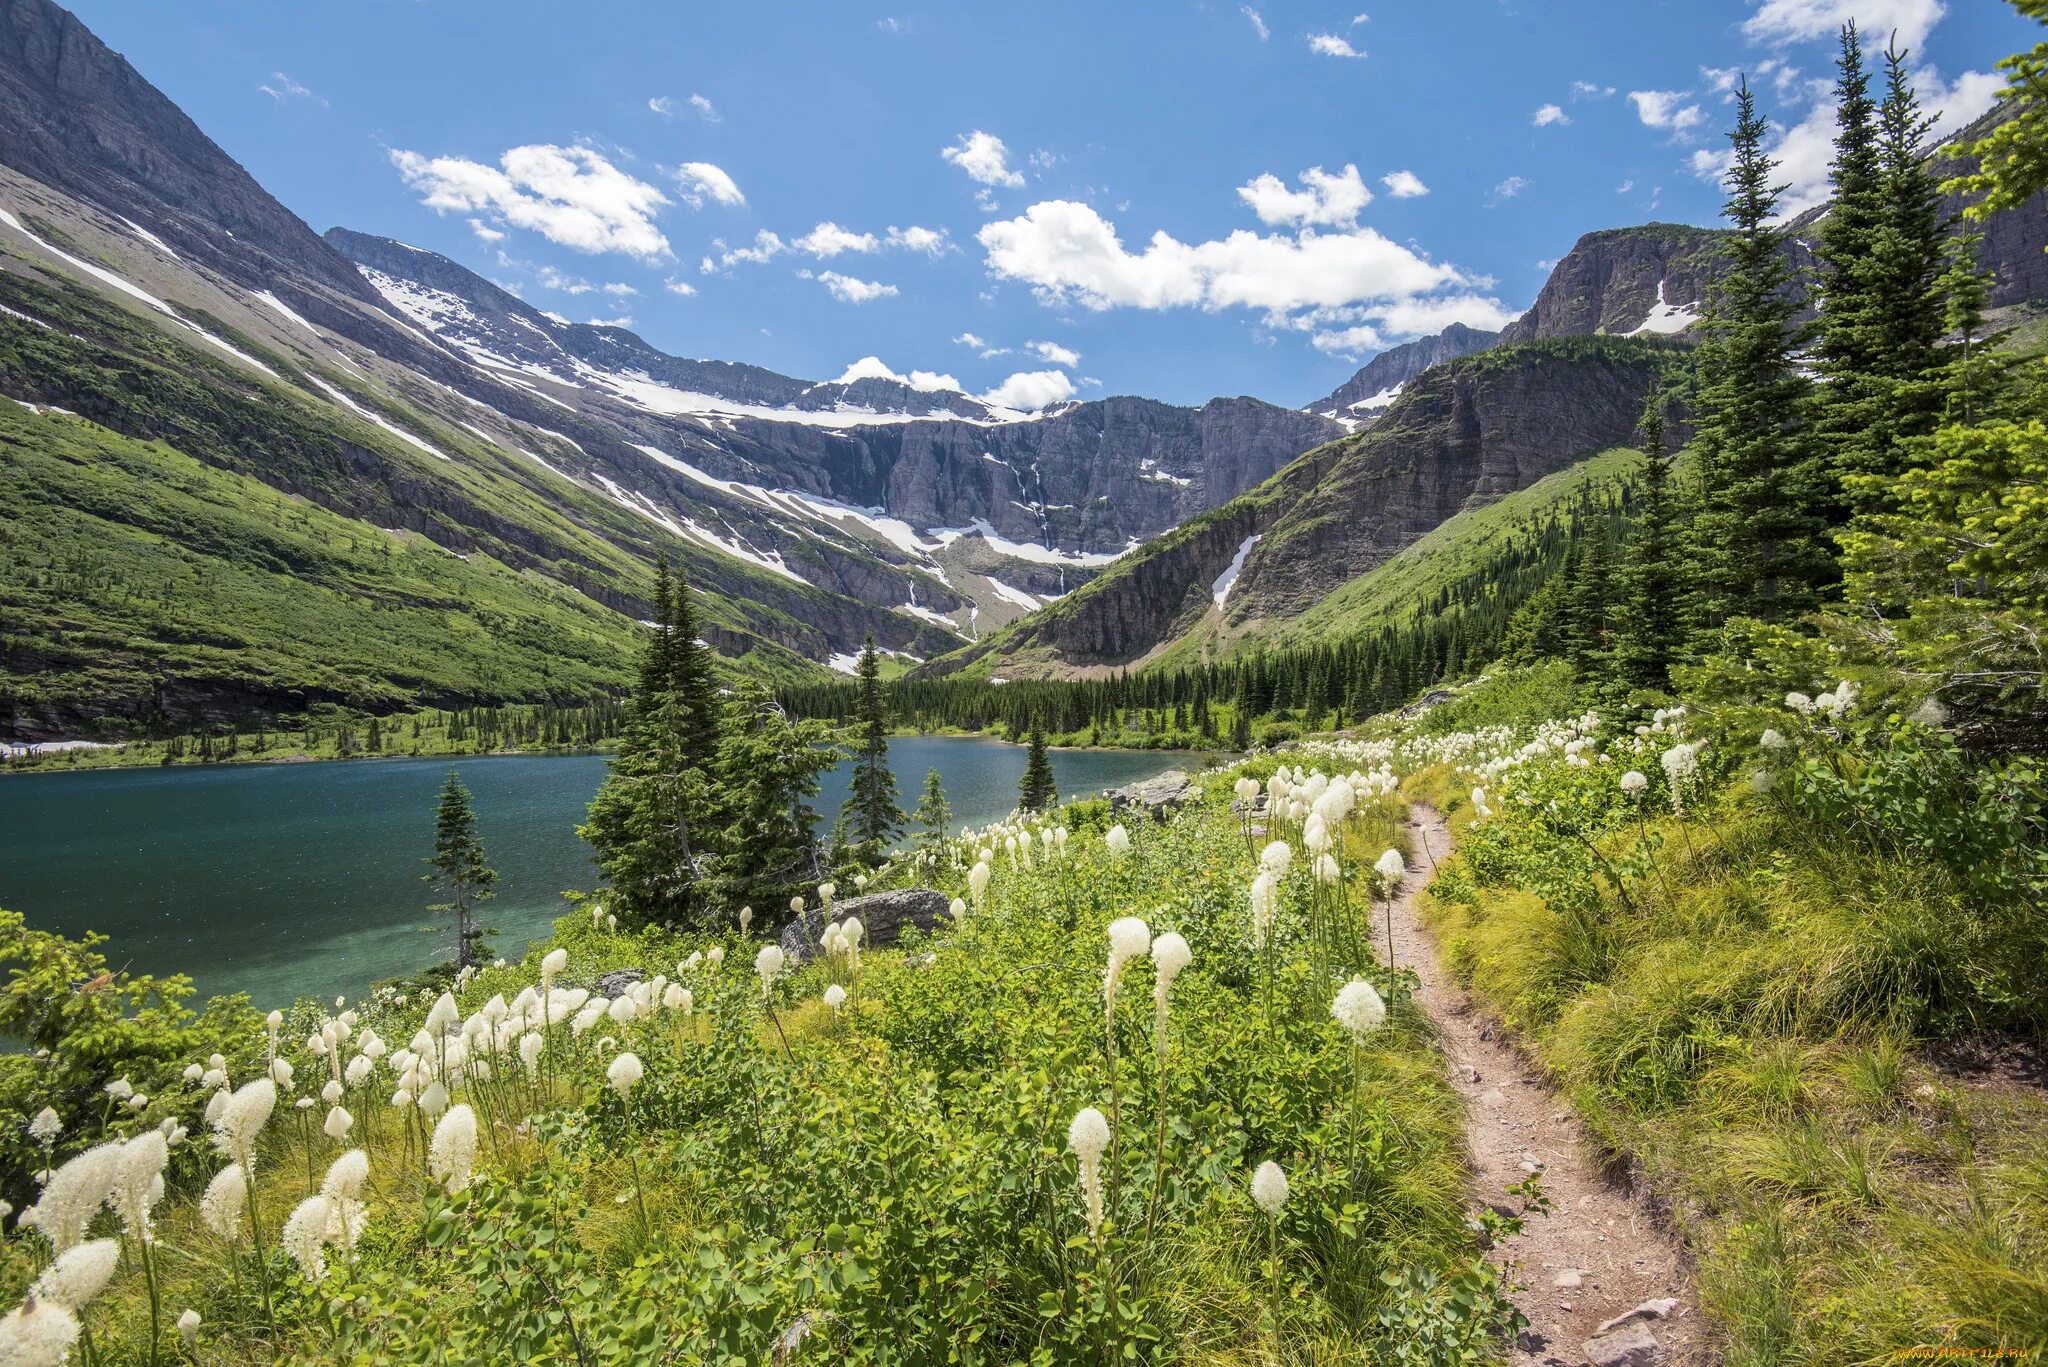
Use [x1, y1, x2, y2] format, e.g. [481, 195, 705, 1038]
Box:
[76, 0, 2040, 406]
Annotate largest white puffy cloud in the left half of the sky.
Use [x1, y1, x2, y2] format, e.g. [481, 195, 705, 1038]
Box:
[391, 143, 670, 260]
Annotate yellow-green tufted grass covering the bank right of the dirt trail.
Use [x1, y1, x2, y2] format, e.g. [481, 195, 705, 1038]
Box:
[1411, 754, 2048, 1367]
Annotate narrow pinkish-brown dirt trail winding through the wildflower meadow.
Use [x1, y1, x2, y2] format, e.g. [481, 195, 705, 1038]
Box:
[1393, 805, 1716, 1367]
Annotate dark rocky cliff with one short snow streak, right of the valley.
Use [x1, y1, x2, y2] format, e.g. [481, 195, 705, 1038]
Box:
[926, 338, 1679, 676]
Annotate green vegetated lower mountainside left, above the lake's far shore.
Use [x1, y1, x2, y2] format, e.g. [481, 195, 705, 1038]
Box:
[0, 259, 858, 734]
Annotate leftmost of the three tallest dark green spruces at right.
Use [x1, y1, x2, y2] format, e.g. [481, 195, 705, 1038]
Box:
[1686, 80, 1837, 633]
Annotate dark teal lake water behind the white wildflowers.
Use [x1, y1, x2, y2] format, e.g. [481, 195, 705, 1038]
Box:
[0, 736, 1186, 1008]
